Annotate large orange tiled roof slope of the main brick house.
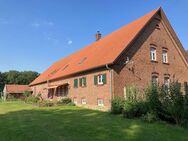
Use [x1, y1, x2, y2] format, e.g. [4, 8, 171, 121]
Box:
[30, 8, 161, 85]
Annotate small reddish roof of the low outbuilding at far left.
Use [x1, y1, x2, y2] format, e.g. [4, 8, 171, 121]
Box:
[5, 84, 31, 93]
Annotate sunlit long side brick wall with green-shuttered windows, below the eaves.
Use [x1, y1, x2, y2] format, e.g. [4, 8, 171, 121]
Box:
[31, 68, 111, 110]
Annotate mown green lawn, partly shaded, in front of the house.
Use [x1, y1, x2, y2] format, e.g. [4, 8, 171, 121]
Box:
[0, 102, 188, 141]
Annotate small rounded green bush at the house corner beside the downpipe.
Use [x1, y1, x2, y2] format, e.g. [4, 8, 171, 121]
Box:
[111, 97, 125, 114]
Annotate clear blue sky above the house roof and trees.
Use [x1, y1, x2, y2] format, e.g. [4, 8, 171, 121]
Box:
[0, 0, 188, 72]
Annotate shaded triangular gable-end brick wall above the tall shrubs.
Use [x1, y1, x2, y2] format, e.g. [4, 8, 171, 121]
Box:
[113, 13, 188, 96]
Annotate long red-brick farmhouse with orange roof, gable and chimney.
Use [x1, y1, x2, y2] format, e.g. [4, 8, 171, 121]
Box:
[30, 8, 188, 110]
